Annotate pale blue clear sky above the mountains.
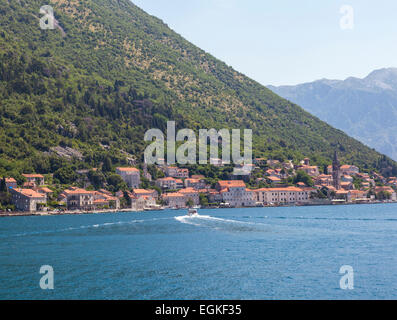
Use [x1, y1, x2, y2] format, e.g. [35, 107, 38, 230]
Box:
[132, 0, 397, 85]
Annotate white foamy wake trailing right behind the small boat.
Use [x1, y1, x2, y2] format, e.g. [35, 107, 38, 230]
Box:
[175, 214, 269, 232]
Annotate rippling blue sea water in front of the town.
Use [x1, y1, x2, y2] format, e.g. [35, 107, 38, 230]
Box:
[0, 204, 397, 299]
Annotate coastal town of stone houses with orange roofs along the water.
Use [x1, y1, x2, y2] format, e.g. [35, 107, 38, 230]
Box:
[1, 153, 397, 215]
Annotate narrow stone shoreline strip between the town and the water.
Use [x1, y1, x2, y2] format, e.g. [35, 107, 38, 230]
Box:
[0, 201, 397, 218]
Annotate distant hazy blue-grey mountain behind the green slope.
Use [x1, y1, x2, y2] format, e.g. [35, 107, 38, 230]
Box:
[268, 68, 397, 160]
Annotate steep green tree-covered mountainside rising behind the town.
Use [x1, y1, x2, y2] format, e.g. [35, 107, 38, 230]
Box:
[0, 0, 397, 175]
